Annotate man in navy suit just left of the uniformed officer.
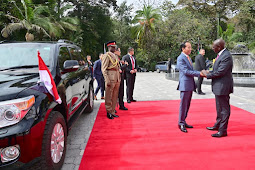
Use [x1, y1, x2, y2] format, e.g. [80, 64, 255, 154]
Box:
[93, 53, 105, 100]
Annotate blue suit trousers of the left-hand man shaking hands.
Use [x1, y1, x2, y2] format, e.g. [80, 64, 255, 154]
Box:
[178, 91, 193, 125]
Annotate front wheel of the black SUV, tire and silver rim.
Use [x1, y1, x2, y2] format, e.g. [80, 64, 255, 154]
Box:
[39, 111, 67, 170]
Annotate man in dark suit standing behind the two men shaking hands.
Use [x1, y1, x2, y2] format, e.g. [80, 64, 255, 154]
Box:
[195, 49, 206, 95]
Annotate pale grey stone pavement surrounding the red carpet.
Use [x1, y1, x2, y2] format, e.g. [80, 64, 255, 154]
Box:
[62, 72, 255, 170]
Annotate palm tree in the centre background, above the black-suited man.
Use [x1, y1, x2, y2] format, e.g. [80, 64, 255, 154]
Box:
[133, 5, 161, 48]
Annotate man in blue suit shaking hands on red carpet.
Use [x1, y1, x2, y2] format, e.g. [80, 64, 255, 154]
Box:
[177, 41, 203, 133]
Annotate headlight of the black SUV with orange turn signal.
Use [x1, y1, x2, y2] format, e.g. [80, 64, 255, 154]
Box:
[0, 96, 35, 128]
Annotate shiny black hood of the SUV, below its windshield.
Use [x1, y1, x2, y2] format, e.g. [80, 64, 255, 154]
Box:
[0, 69, 39, 101]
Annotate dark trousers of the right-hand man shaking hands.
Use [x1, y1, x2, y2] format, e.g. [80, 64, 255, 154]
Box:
[214, 95, 230, 133]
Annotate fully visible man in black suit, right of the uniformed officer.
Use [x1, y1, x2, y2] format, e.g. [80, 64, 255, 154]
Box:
[122, 47, 137, 103]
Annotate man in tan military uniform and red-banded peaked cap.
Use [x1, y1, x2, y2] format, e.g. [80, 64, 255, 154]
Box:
[102, 41, 120, 119]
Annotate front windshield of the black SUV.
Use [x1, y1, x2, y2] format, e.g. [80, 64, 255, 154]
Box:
[0, 43, 54, 69]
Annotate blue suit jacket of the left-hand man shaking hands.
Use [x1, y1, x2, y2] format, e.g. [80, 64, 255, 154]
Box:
[177, 53, 200, 91]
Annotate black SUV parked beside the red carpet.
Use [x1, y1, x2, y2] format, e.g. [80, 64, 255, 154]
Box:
[0, 40, 94, 169]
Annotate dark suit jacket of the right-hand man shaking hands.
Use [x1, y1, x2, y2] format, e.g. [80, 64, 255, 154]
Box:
[206, 49, 234, 95]
